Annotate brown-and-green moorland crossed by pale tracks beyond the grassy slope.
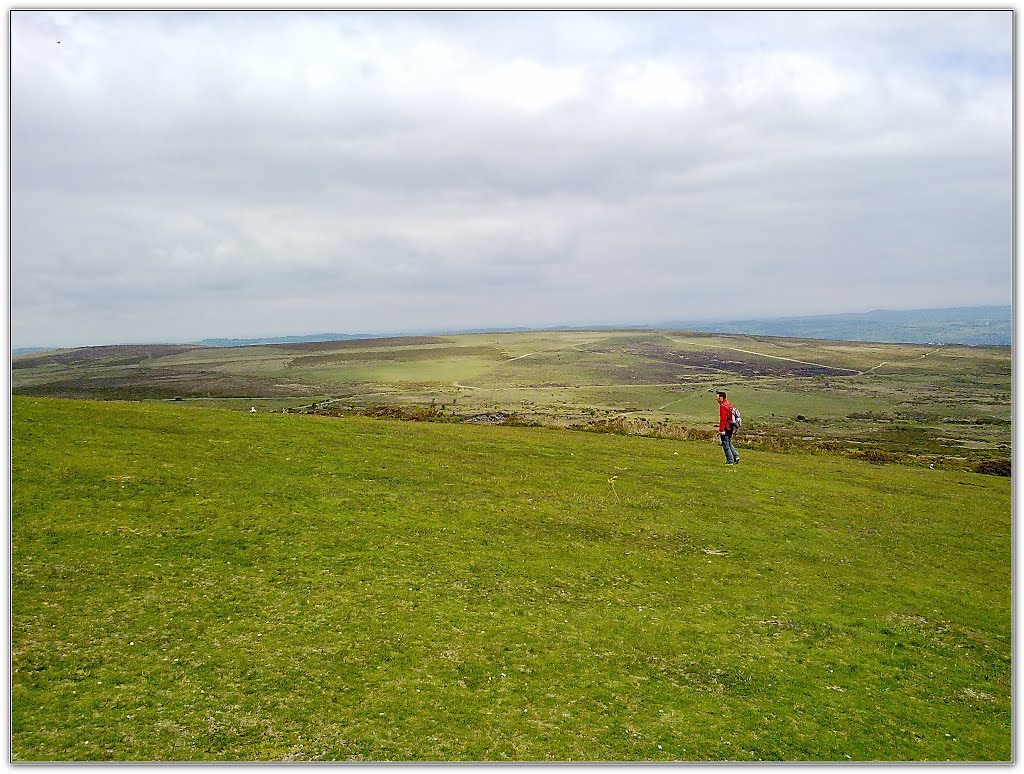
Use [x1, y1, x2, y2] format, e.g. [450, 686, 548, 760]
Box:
[11, 330, 1012, 473]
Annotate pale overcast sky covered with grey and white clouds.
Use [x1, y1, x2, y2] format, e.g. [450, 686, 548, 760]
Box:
[9, 9, 1013, 347]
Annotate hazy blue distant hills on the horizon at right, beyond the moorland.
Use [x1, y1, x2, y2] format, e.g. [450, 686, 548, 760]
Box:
[665, 306, 1013, 346]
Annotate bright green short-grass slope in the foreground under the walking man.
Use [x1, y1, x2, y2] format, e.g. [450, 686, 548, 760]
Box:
[11, 395, 1012, 761]
